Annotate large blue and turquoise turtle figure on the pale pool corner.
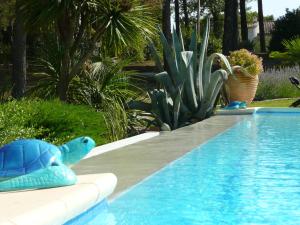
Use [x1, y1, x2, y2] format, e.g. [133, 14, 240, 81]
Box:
[0, 137, 95, 191]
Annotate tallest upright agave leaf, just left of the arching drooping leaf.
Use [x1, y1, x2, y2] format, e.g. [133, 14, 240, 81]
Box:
[196, 17, 210, 102]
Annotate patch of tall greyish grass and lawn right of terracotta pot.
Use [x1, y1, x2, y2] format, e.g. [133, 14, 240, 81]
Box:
[255, 67, 300, 101]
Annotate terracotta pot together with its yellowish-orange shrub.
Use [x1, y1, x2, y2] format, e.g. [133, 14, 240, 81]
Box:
[225, 49, 263, 105]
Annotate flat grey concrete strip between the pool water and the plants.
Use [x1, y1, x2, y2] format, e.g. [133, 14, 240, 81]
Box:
[73, 115, 250, 199]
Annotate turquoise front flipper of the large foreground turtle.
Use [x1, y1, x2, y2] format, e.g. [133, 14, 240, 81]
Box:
[0, 165, 77, 191]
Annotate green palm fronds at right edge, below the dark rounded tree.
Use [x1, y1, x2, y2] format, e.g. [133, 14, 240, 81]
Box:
[270, 38, 300, 66]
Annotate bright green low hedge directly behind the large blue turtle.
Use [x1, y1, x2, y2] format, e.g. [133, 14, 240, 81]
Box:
[0, 100, 107, 145]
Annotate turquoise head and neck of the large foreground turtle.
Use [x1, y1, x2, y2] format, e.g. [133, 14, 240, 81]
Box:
[59, 137, 96, 166]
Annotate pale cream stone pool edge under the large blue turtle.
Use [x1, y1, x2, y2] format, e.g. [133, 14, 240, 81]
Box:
[0, 173, 117, 225]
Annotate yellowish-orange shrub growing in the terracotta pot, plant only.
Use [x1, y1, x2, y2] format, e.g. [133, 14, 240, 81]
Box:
[228, 49, 263, 76]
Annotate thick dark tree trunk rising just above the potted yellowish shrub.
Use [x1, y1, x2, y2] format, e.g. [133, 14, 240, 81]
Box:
[223, 0, 239, 55]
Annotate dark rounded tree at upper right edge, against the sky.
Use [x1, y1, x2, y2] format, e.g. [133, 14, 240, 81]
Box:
[269, 8, 300, 51]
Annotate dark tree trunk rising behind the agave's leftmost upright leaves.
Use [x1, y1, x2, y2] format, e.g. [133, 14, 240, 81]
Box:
[162, 0, 172, 71]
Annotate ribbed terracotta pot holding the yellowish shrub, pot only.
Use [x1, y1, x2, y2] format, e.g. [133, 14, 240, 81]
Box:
[225, 73, 259, 105]
